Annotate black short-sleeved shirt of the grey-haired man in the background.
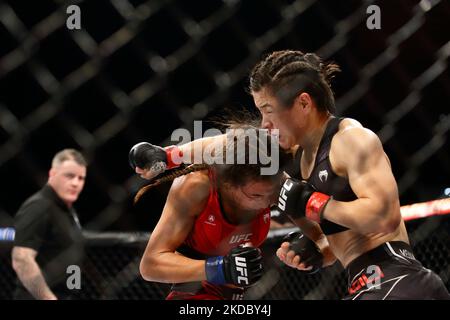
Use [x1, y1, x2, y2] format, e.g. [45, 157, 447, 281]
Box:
[14, 184, 84, 299]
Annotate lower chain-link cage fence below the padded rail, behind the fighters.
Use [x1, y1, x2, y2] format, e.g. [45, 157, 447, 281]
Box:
[0, 217, 450, 300]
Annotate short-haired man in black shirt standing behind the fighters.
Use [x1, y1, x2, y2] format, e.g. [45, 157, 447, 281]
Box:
[12, 149, 86, 300]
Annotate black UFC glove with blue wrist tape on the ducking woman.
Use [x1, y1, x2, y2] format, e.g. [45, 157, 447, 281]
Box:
[205, 246, 263, 287]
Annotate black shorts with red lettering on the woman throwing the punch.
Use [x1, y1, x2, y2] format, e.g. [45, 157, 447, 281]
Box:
[344, 241, 450, 300]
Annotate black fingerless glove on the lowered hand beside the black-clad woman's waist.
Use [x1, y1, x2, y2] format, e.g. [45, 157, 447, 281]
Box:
[281, 231, 323, 274]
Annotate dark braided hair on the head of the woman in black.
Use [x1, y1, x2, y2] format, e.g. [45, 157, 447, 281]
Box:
[249, 50, 340, 113]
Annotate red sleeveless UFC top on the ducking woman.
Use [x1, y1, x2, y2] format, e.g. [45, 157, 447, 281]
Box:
[184, 170, 270, 256]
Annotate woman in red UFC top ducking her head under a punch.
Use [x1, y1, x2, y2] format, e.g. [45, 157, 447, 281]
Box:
[133, 127, 294, 299]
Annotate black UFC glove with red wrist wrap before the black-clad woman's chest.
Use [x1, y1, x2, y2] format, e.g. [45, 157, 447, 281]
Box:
[278, 178, 330, 223]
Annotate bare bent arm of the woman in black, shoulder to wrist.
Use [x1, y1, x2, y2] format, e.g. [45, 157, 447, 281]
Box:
[322, 127, 401, 234]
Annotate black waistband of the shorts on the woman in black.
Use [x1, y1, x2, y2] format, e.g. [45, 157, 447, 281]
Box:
[346, 241, 420, 277]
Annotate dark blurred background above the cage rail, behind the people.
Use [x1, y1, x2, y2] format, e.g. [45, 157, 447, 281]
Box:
[0, 0, 450, 231]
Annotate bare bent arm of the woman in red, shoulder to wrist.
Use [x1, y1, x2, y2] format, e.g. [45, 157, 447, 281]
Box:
[140, 174, 209, 283]
